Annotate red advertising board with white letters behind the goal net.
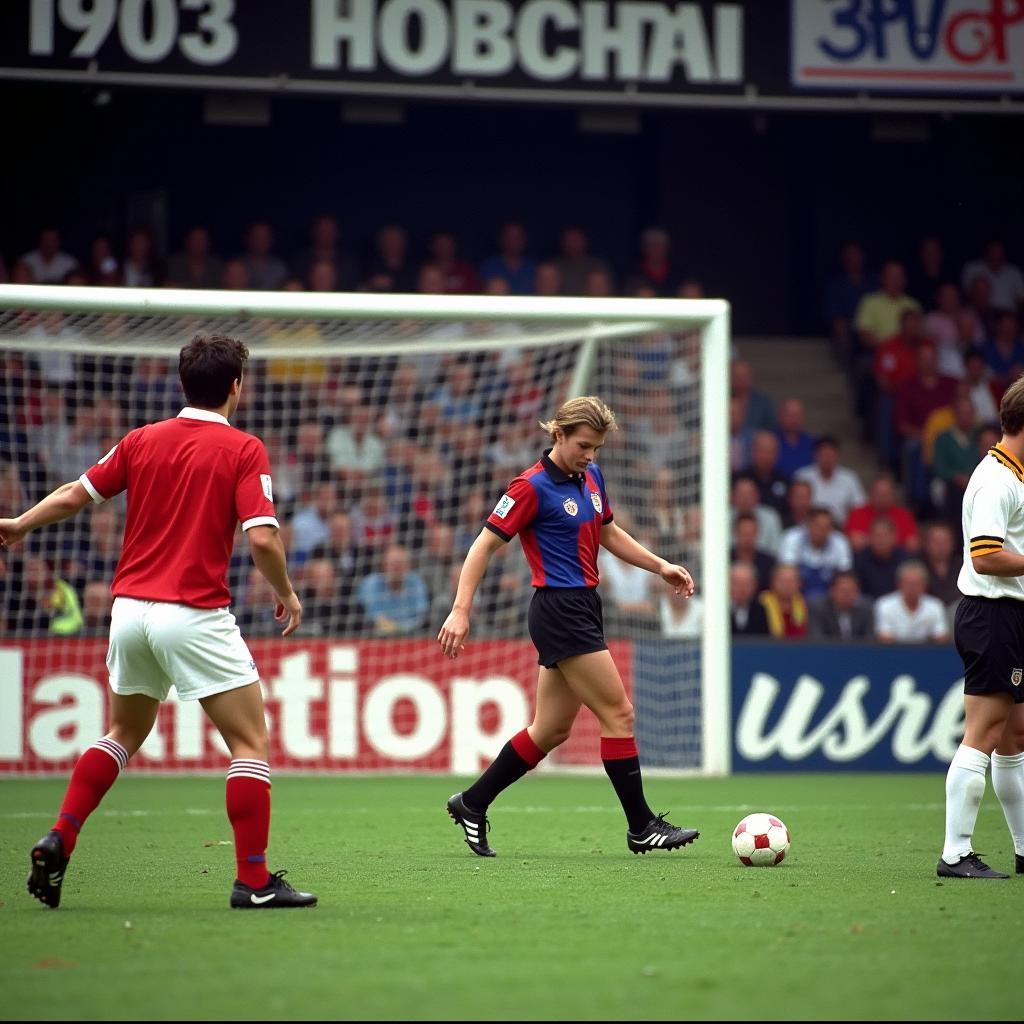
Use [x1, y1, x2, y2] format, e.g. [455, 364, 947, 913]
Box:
[0, 639, 631, 774]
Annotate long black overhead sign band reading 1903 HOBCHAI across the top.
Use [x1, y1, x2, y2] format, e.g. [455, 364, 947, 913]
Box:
[0, 0, 1024, 113]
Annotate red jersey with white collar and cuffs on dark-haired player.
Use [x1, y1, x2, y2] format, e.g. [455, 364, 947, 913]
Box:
[79, 409, 278, 608]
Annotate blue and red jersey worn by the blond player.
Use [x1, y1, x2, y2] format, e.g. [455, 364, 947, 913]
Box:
[484, 449, 612, 587]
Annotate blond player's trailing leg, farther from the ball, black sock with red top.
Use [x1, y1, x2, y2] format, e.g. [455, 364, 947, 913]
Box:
[447, 668, 580, 857]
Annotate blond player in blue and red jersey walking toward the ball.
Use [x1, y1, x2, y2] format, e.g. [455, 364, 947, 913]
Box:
[437, 397, 698, 857]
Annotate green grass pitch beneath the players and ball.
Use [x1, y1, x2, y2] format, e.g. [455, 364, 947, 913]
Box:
[0, 775, 1024, 1021]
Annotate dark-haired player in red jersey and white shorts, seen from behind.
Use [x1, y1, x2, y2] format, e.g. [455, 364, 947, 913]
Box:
[0, 335, 316, 909]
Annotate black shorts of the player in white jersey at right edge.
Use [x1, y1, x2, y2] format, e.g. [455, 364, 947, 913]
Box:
[953, 597, 1024, 703]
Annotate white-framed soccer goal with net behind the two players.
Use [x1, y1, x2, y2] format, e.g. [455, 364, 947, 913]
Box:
[0, 286, 729, 774]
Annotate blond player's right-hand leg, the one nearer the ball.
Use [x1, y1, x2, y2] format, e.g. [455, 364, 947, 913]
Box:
[558, 650, 699, 853]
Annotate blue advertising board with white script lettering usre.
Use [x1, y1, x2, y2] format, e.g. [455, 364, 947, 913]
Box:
[732, 643, 964, 771]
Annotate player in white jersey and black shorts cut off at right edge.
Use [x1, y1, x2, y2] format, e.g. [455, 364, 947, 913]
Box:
[937, 377, 1024, 879]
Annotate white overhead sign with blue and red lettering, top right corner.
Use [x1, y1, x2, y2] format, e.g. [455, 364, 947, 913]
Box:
[791, 0, 1024, 93]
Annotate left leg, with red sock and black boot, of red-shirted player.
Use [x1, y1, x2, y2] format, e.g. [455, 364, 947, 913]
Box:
[28, 693, 160, 907]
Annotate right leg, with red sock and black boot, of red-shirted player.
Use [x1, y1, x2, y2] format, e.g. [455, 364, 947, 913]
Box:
[200, 680, 316, 909]
